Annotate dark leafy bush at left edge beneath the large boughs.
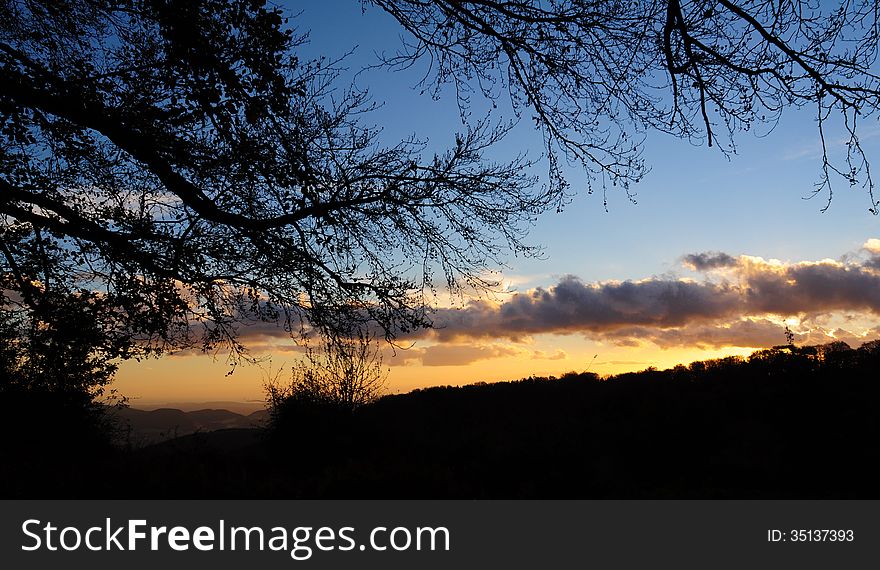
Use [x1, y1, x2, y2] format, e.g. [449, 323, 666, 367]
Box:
[0, 299, 123, 482]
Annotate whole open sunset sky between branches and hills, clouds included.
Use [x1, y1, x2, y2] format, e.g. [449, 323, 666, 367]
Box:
[115, 0, 880, 407]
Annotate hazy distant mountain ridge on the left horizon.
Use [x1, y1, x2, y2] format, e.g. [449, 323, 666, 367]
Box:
[112, 408, 269, 445]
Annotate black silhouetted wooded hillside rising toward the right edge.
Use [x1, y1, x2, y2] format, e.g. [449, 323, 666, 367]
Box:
[288, 342, 880, 498]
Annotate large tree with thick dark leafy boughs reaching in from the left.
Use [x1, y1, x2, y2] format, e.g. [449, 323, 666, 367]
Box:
[0, 0, 548, 370]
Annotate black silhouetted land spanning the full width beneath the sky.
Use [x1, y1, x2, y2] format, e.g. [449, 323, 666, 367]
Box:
[0, 343, 880, 499]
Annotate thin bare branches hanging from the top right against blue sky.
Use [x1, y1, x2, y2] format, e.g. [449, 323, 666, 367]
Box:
[369, 0, 880, 209]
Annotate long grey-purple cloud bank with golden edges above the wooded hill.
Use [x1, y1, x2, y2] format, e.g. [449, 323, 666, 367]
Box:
[410, 240, 880, 347]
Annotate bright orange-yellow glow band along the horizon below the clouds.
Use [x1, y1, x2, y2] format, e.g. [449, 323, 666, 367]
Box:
[113, 335, 757, 408]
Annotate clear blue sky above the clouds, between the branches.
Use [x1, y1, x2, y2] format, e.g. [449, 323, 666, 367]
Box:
[289, 0, 880, 284]
